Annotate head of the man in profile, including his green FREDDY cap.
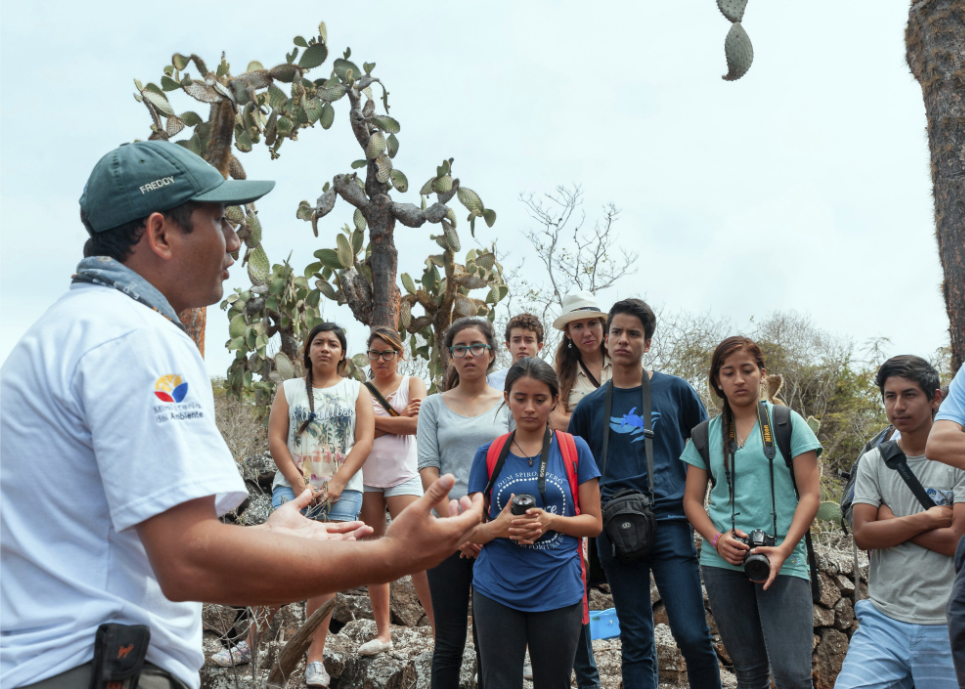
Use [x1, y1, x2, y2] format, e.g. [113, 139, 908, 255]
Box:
[78, 141, 275, 317]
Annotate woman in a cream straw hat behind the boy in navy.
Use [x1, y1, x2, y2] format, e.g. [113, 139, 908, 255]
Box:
[550, 291, 611, 431]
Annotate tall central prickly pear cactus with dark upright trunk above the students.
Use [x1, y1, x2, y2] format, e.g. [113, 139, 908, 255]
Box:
[295, 33, 509, 387]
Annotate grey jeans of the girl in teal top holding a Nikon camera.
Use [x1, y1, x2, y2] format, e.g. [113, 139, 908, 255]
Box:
[703, 567, 814, 689]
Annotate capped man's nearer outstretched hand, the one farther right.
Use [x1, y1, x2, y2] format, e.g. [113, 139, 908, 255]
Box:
[384, 474, 483, 573]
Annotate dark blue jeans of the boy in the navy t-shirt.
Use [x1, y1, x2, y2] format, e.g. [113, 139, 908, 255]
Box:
[596, 519, 720, 689]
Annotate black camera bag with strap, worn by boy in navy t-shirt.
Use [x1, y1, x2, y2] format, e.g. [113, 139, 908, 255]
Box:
[600, 369, 657, 564]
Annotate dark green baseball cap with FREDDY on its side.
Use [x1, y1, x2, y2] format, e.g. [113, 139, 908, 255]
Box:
[80, 141, 275, 232]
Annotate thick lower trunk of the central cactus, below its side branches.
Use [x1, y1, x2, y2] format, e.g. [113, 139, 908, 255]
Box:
[366, 193, 402, 329]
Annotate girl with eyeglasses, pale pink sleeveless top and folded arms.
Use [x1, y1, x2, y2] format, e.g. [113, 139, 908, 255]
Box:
[358, 326, 435, 656]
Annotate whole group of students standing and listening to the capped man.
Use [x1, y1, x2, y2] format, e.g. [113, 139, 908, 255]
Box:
[214, 286, 965, 689]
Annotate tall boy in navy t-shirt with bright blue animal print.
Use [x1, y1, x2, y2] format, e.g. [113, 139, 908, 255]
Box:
[568, 299, 720, 689]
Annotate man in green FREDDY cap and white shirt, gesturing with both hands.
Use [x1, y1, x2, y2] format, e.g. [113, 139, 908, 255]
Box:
[0, 141, 482, 689]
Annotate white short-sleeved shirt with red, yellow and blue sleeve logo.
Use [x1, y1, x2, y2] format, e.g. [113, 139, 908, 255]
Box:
[0, 284, 247, 689]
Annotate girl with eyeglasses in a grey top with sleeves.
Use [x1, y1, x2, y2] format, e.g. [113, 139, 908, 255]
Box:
[417, 318, 515, 689]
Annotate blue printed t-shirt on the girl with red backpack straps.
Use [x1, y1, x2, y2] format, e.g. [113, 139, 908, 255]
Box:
[469, 433, 600, 612]
